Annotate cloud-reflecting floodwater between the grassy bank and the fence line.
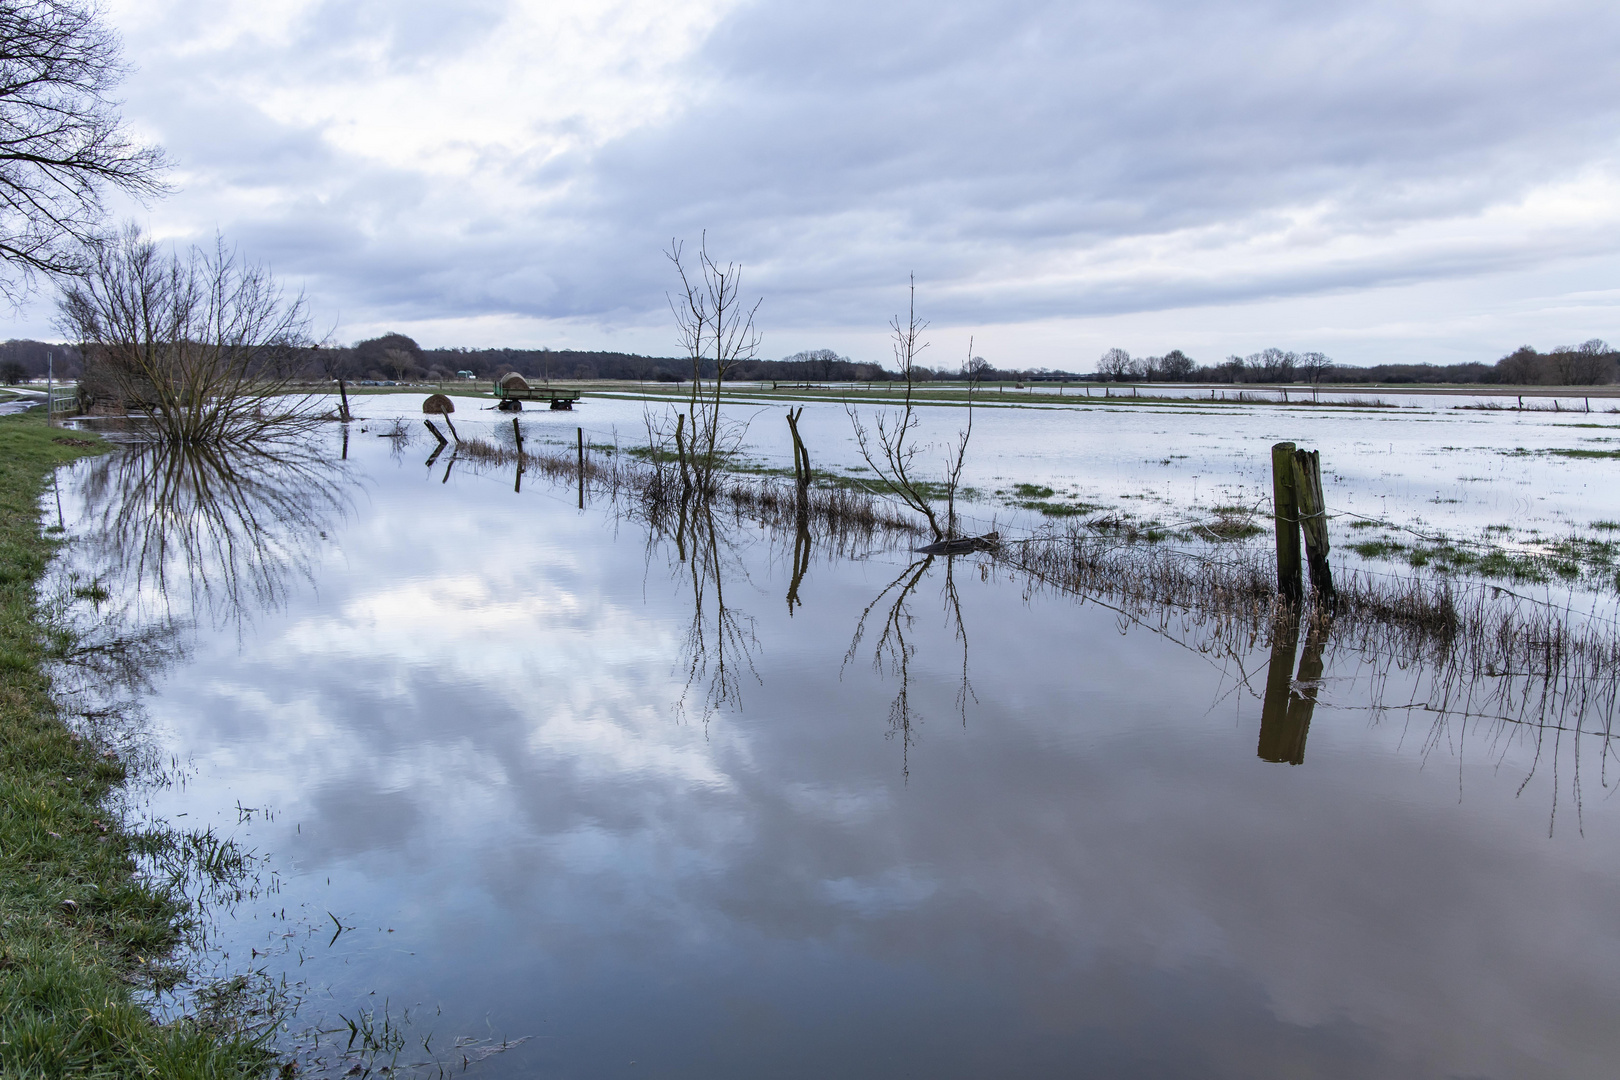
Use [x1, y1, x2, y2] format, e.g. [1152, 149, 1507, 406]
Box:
[44, 417, 1620, 1078]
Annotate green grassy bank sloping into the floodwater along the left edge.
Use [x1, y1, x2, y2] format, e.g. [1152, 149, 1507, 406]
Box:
[0, 415, 267, 1080]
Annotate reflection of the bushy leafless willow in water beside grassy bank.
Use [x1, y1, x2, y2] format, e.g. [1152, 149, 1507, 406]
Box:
[41, 442, 347, 772]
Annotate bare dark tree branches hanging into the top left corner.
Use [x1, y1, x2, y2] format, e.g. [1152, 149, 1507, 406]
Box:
[0, 0, 165, 303]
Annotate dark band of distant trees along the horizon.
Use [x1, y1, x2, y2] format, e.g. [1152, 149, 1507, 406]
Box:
[0, 334, 1620, 393]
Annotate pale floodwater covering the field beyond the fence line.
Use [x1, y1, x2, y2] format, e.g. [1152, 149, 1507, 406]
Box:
[341, 387, 1620, 565]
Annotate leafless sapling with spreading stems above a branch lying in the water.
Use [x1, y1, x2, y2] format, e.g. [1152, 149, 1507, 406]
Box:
[844, 282, 977, 541]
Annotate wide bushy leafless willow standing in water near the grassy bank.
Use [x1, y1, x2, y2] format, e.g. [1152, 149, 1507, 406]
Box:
[58, 225, 318, 445]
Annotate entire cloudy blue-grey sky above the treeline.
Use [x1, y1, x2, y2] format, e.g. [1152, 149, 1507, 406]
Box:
[13, 0, 1620, 369]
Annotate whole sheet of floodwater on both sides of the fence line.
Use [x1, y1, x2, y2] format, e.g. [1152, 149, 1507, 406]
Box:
[42, 395, 1620, 1077]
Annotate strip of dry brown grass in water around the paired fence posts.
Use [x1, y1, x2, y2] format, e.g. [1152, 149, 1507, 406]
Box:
[991, 528, 1620, 738]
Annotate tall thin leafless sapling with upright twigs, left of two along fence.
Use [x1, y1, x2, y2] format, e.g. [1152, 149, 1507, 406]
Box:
[664, 233, 761, 489]
